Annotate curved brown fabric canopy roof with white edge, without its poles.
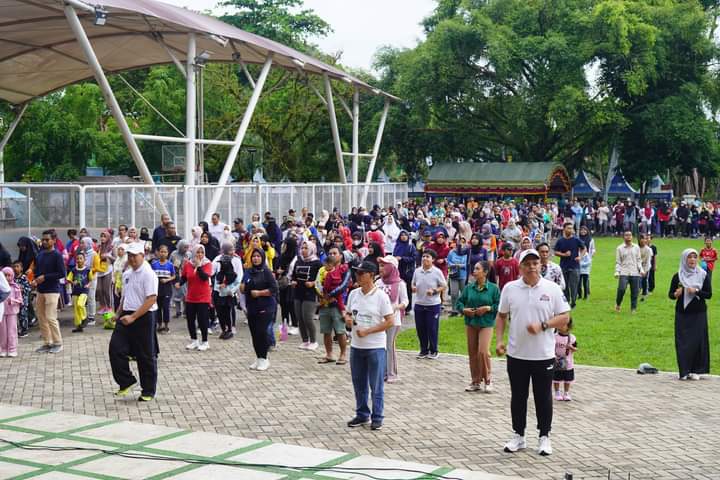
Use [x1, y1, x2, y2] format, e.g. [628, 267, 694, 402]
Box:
[0, 0, 395, 104]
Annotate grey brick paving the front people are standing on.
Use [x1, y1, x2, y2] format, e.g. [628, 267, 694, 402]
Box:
[0, 311, 720, 480]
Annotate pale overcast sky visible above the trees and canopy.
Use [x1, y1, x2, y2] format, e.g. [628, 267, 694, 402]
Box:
[163, 0, 435, 70]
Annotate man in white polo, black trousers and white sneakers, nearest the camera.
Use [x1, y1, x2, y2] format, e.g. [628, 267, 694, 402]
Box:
[496, 249, 570, 455]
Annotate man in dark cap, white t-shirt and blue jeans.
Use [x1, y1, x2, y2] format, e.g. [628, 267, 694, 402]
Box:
[345, 262, 395, 430]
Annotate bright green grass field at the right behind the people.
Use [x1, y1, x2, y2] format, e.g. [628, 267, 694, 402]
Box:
[397, 238, 720, 374]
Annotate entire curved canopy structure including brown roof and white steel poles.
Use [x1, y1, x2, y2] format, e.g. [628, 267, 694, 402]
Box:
[0, 0, 397, 234]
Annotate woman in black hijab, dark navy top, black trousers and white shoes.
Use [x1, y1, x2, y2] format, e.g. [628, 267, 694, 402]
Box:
[240, 248, 278, 371]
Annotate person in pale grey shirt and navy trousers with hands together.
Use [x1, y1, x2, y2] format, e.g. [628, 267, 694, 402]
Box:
[412, 249, 447, 360]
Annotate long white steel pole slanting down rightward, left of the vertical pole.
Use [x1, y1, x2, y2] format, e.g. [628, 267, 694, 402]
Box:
[64, 5, 155, 190]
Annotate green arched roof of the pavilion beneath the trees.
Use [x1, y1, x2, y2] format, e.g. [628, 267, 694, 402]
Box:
[425, 162, 570, 195]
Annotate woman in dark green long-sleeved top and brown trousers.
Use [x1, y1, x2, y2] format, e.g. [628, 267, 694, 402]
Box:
[455, 262, 500, 393]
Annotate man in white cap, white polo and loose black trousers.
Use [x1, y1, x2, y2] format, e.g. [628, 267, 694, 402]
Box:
[109, 242, 158, 402]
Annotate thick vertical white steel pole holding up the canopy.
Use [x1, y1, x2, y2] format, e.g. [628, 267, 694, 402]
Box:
[184, 33, 197, 238]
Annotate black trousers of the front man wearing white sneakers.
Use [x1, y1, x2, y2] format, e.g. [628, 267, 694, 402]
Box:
[507, 357, 555, 437]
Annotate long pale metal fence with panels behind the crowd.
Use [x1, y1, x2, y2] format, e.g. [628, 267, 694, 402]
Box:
[0, 183, 408, 256]
